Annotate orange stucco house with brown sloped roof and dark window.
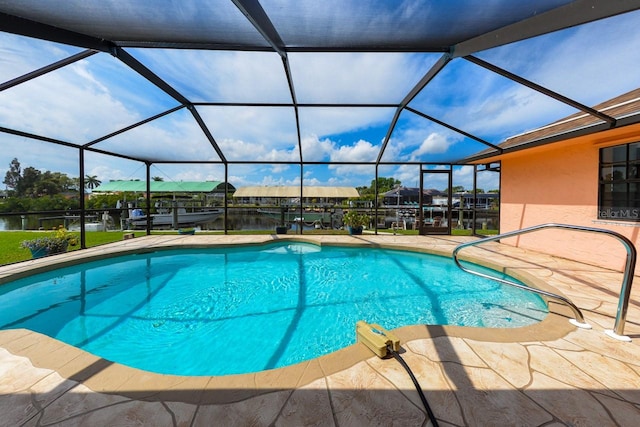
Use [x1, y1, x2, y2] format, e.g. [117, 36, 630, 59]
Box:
[471, 89, 640, 269]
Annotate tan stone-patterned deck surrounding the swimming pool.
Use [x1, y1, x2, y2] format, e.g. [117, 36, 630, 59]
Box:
[0, 235, 640, 427]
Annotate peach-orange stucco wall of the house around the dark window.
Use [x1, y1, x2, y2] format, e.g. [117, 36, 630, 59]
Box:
[500, 126, 640, 274]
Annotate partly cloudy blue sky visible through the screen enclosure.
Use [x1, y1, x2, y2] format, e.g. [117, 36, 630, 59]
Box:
[0, 7, 640, 194]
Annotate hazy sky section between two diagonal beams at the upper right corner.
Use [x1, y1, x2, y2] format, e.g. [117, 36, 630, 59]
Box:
[483, 11, 640, 105]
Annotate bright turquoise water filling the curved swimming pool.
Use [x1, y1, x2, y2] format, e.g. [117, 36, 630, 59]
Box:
[0, 242, 547, 375]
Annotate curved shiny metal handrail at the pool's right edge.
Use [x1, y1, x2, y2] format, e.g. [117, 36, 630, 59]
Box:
[453, 223, 637, 341]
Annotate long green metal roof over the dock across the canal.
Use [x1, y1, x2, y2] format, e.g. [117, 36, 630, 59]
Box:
[93, 181, 235, 193]
